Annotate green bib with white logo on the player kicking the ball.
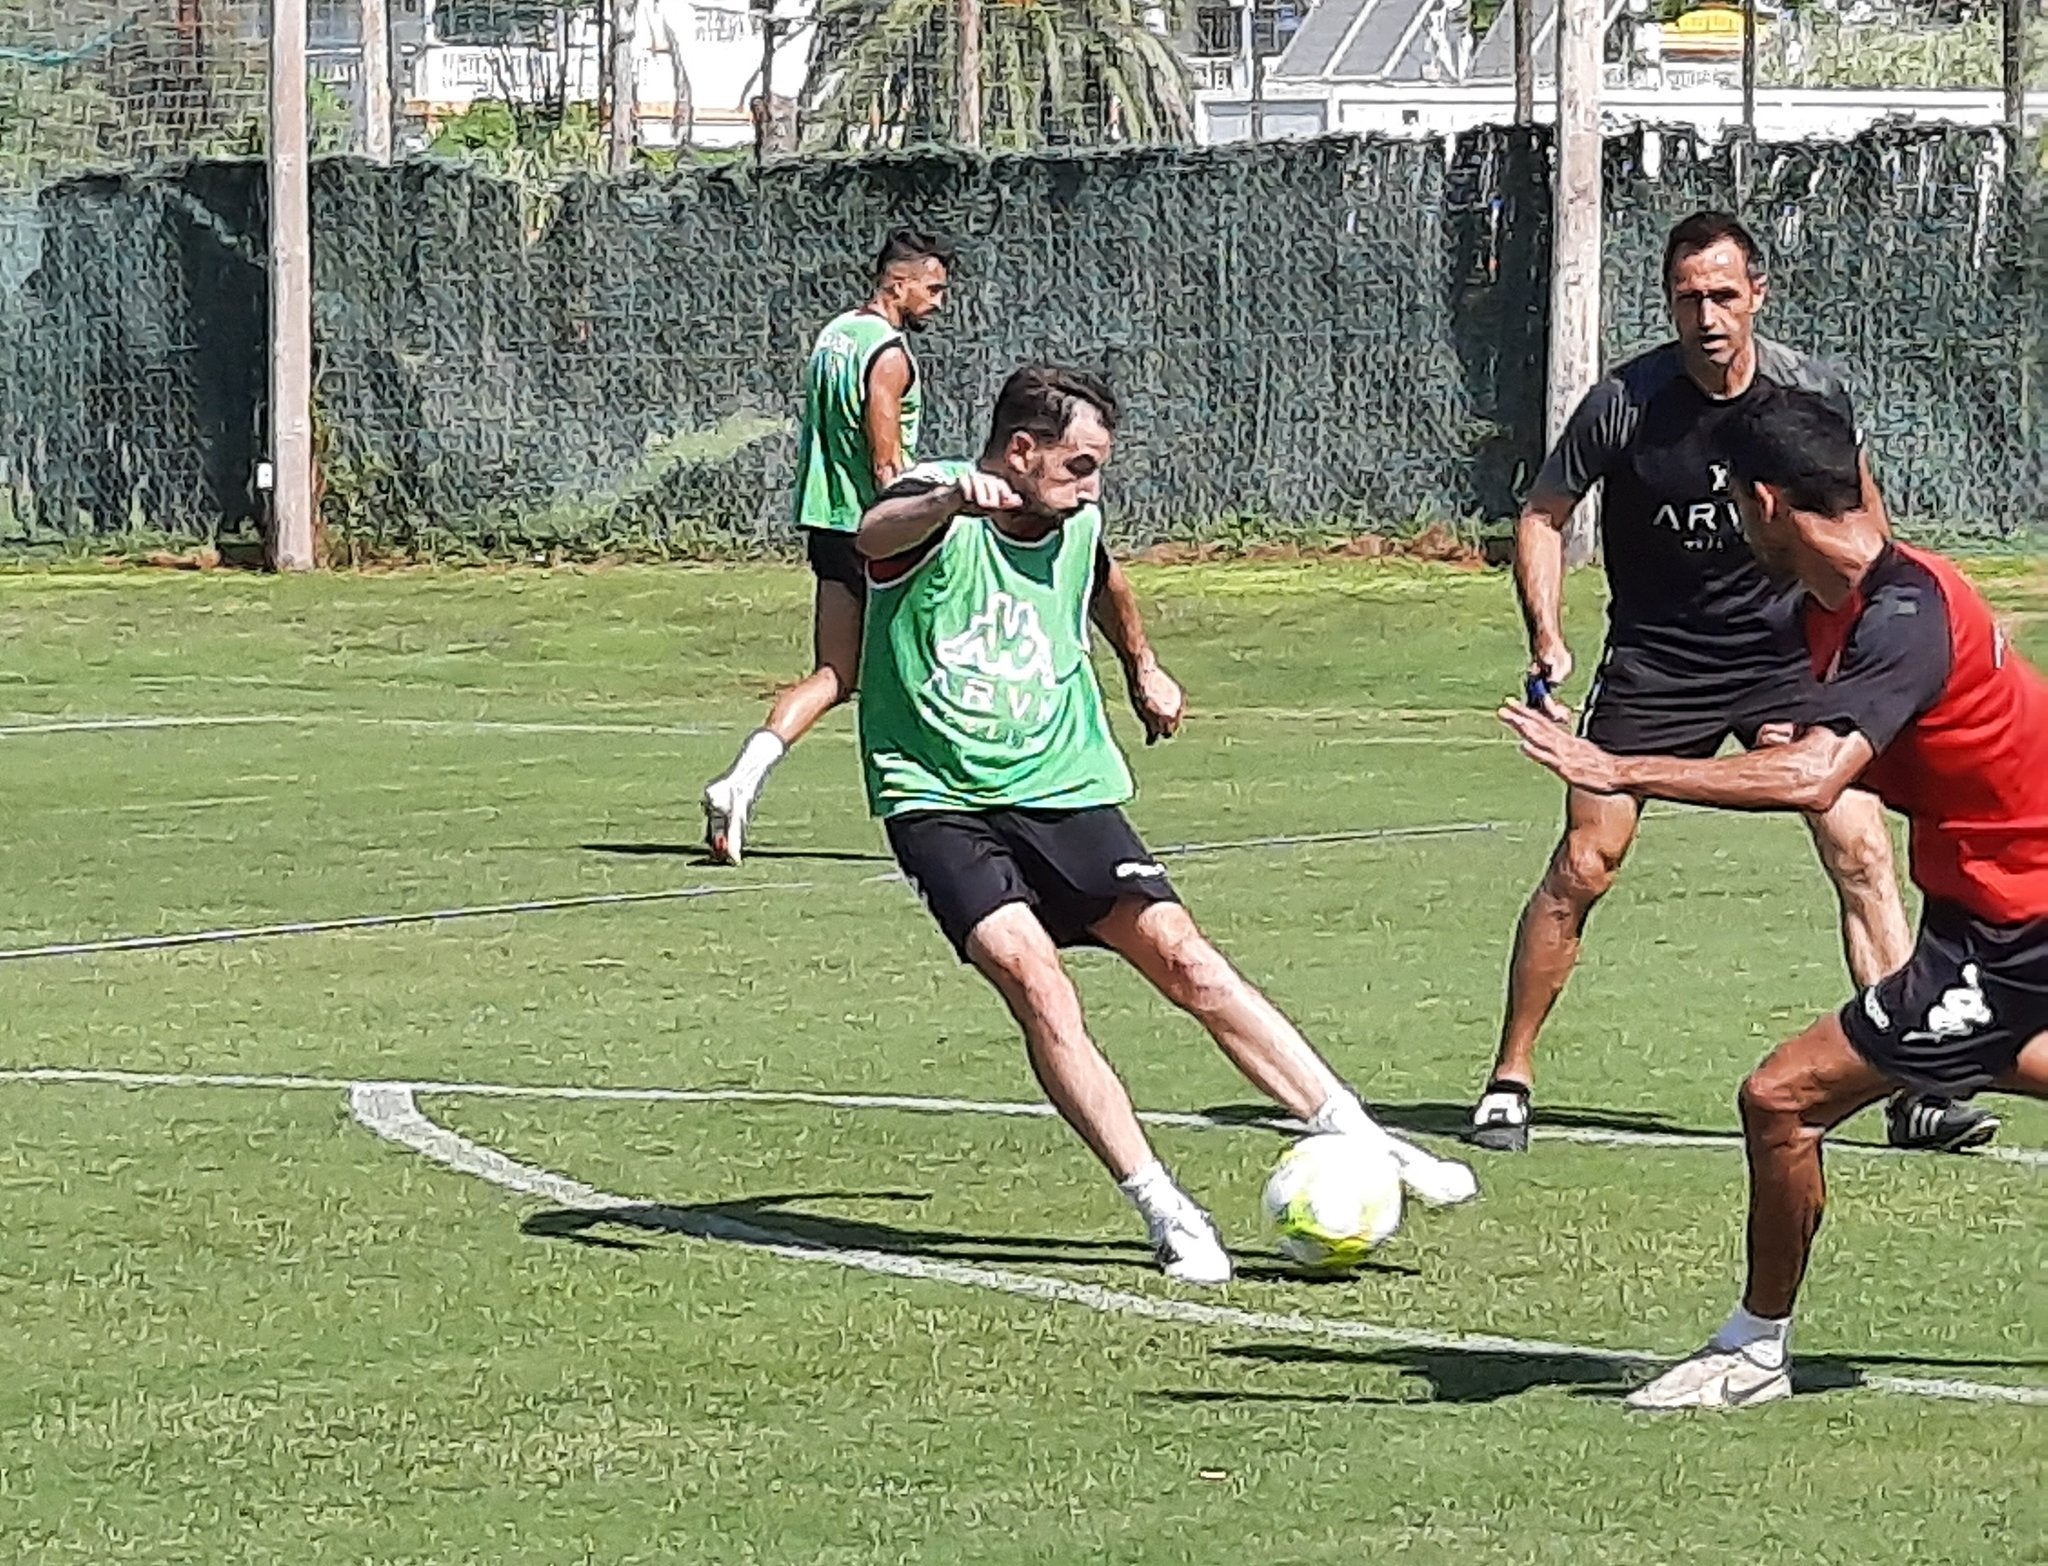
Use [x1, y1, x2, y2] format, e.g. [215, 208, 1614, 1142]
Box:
[860, 463, 1133, 817]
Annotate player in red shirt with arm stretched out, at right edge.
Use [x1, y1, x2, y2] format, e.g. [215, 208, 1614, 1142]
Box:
[1501, 389, 2048, 1408]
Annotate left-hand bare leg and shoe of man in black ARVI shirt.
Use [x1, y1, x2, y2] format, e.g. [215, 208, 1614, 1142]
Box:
[1468, 788, 1642, 1152]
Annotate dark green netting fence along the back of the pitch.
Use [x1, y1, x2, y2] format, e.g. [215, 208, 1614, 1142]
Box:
[0, 127, 2048, 555]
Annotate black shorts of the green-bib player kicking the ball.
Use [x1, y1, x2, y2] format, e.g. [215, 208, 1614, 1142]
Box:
[883, 804, 1180, 962]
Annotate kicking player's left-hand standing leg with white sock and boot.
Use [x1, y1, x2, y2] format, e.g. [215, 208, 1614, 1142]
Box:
[967, 903, 1231, 1284]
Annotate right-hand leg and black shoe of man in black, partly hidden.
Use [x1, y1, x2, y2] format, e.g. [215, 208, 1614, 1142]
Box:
[1806, 788, 1999, 1152]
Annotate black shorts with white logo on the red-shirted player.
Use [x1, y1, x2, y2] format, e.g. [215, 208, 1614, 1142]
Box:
[1841, 899, 2048, 1099]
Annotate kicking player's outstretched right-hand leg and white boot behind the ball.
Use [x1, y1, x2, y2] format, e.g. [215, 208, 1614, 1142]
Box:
[1094, 897, 1479, 1206]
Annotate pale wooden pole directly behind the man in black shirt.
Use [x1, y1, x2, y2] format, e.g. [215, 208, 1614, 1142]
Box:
[1544, 0, 1606, 565]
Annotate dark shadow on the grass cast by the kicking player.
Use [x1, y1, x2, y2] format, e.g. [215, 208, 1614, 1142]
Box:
[520, 1191, 1415, 1284]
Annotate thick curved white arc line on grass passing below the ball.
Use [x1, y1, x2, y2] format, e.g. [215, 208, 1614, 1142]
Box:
[348, 1083, 2048, 1406]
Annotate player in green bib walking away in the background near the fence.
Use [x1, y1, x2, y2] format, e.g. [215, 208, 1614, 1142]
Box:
[705, 229, 952, 864]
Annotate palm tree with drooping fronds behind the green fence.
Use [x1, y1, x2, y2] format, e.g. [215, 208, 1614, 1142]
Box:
[803, 0, 1192, 149]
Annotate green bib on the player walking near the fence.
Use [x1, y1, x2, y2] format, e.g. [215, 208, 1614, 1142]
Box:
[797, 309, 924, 532]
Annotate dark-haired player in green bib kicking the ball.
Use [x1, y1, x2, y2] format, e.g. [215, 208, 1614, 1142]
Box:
[858, 364, 1479, 1284]
